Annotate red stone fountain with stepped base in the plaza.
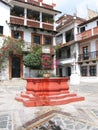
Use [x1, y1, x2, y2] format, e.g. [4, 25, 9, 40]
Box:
[16, 78, 84, 107]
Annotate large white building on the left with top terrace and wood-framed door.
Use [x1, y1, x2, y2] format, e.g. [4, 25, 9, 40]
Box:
[0, 0, 61, 80]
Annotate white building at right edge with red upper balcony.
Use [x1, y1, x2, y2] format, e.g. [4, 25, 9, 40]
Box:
[77, 16, 98, 83]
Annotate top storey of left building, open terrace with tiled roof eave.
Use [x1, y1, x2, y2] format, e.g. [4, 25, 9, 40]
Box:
[10, 0, 61, 30]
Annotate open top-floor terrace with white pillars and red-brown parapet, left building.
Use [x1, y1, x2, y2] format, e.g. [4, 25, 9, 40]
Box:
[10, 7, 55, 30]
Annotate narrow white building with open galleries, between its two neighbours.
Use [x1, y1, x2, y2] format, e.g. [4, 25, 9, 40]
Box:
[56, 15, 84, 84]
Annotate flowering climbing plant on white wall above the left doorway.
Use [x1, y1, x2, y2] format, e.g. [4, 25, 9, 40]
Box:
[0, 37, 24, 70]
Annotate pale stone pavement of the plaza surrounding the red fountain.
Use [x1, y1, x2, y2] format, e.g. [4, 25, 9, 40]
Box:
[0, 80, 98, 130]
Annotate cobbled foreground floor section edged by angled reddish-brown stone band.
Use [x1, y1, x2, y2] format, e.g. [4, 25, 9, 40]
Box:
[21, 110, 98, 130]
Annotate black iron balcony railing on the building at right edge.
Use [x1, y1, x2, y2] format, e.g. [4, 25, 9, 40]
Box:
[78, 51, 98, 61]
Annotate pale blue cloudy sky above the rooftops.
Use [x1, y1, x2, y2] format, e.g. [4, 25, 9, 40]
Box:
[43, 0, 98, 18]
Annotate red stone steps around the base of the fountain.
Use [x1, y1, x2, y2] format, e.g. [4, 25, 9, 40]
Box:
[15, 93, 84, 107]
